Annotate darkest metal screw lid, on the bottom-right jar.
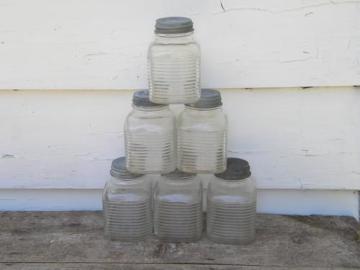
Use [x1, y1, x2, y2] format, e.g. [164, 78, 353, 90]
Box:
[215, 158, 251, 180]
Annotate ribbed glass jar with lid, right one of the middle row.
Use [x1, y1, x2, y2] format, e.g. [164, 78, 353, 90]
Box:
[177, 89, 227, 173]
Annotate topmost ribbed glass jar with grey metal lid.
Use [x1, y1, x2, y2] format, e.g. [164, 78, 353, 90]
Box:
[148, 17, 200, 104]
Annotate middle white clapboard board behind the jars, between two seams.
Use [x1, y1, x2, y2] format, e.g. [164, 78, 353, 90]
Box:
[0, 87, 360, 190]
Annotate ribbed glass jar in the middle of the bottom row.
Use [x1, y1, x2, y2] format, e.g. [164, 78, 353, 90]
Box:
[154, 171, 203, 242]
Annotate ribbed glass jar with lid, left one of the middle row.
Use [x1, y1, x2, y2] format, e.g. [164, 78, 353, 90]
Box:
[125, 90, 176, 174]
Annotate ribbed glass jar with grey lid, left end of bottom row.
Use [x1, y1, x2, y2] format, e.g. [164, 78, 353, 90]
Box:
[103, 157, 152, 241]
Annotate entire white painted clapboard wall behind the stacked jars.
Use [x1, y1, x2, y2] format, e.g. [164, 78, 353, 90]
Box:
[0, 0, 360, 216]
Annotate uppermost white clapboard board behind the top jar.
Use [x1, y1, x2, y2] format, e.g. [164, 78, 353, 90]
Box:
[0, 0, 360, 89]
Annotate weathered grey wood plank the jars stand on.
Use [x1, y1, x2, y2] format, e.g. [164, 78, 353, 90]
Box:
[0, 212, 360, 269]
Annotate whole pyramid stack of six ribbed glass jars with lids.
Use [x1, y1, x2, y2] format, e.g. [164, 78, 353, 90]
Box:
[103, 17, 256, 244]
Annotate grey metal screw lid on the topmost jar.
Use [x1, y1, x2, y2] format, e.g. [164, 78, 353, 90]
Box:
[155, 17, 194, 34]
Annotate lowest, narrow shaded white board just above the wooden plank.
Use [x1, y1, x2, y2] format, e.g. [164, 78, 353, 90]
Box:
[0, 189, 359, 219]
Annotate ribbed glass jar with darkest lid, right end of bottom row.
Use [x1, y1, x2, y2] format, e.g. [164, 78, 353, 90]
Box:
[207, 158, 256, 244]
